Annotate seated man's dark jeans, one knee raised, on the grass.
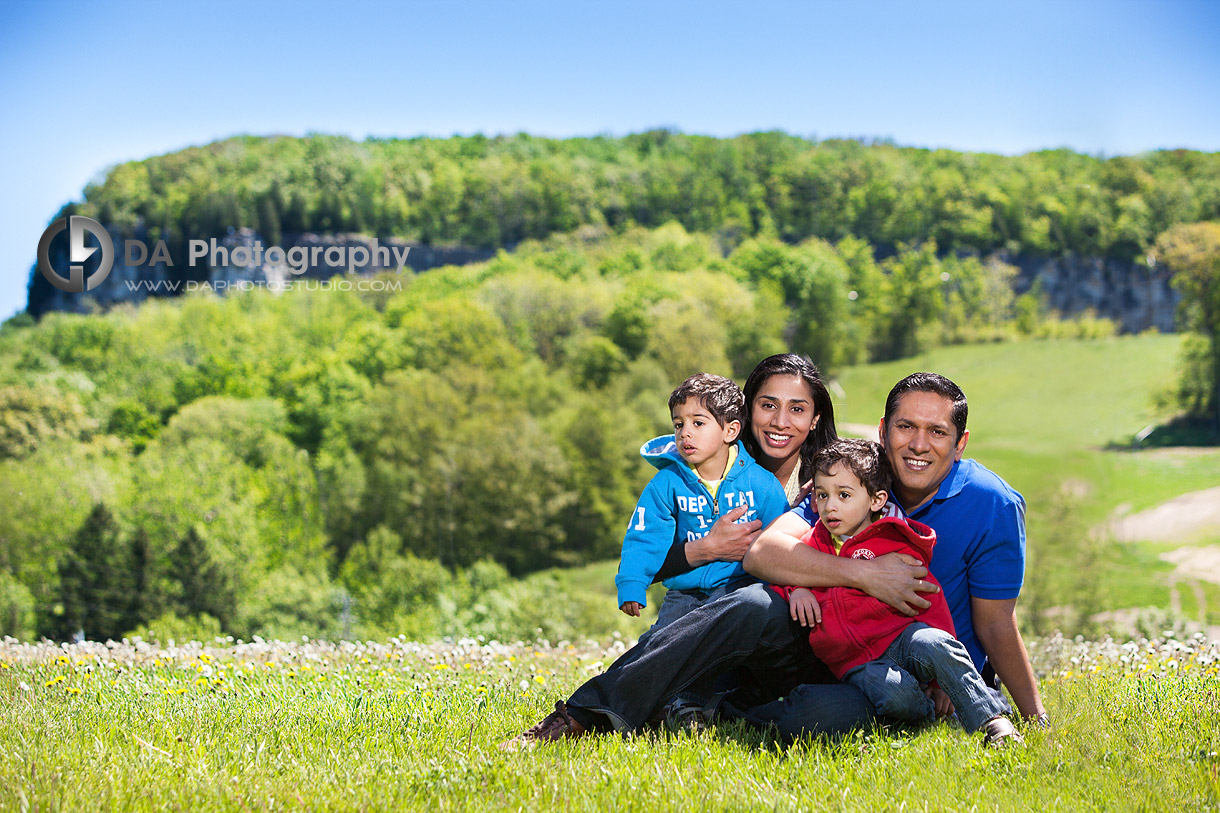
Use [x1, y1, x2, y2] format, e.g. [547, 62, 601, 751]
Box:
[567, 585, 874, 736]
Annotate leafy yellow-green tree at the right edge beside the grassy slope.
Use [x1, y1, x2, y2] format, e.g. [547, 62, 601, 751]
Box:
[1157, 214, 1220, 431]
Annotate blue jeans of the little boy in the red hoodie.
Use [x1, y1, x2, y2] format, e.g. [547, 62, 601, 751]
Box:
[843, 621, 1010, 731]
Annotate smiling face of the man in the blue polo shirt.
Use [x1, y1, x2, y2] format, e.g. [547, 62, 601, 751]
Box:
[881, 392, 970, 511]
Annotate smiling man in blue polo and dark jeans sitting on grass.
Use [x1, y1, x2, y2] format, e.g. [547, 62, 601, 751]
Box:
[504, 372, 1046, 748]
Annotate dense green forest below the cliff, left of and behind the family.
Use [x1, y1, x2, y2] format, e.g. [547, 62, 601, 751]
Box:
[0, 223, 1114, 638]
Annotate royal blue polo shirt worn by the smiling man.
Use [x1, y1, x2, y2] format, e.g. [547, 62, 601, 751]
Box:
[792, 460, 1025, 670]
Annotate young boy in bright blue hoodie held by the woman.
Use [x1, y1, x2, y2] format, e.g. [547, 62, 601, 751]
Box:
[614, 372, 788, 630]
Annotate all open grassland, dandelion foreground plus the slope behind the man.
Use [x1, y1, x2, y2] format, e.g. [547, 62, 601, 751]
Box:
[7, 336, 1220, 811]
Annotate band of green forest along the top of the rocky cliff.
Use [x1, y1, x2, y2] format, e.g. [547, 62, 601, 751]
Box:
[43, 131, 1220, 259]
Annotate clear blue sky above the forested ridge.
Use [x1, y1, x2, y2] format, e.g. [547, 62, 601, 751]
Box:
[0, 0, 1220, 319]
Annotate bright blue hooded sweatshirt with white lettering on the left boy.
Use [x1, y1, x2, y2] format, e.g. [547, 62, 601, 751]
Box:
[614, 435, 788, 607]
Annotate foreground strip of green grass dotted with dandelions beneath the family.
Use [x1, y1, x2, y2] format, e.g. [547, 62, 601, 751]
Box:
[0, 640, 1220, 811]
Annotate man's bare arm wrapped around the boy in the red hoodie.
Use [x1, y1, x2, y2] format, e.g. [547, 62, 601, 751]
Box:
[742, 513, 937, 615]
